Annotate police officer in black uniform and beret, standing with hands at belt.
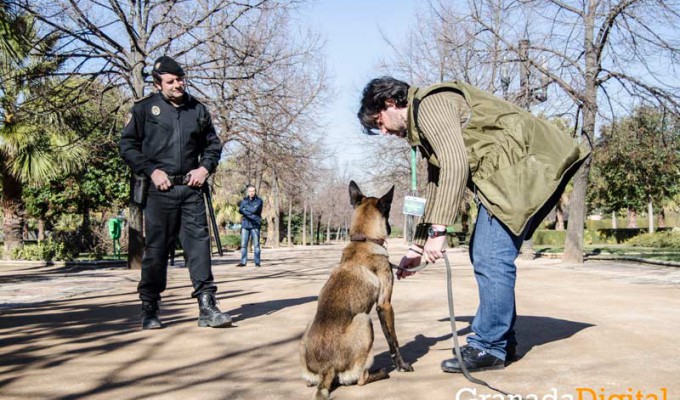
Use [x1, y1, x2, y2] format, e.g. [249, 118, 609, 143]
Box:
[120, 56, 232, 329]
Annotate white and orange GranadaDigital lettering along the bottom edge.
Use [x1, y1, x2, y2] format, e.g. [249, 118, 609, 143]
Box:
[455, 387, 668, 400]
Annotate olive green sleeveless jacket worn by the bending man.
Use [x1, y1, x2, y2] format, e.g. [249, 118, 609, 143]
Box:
[407, 81, 590, 237]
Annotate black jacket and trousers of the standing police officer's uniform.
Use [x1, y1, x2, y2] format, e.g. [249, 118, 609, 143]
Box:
[120, 92, 222, 301]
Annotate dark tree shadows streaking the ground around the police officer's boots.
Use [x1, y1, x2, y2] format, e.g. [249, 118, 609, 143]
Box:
[0, 290, 304, 399]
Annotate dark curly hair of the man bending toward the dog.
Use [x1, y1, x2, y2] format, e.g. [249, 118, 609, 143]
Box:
[357, 76, 410, 135]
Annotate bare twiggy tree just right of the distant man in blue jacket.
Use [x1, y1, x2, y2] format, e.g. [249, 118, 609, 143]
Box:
[203, 10, 327, 247]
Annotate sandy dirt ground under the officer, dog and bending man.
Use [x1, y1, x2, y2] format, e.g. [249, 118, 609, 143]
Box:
[0, 240, 680, 400]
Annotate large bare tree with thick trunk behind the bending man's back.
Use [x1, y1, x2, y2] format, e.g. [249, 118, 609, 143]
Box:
[382, 0, 680, 263]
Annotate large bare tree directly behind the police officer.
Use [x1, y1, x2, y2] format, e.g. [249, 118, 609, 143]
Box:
[17, 0, 310, 268]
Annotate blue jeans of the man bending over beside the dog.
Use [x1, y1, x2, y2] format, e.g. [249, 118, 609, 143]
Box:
[467, 204, 524, 360]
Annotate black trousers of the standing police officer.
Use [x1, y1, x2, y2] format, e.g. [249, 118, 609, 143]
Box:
[137, 185, 217, 301]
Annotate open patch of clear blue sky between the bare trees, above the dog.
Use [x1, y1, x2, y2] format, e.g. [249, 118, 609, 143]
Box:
[297, 0, 420, 180]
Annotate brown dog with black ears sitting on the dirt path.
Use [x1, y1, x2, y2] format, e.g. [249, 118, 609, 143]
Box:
[300, 181, 413, 400]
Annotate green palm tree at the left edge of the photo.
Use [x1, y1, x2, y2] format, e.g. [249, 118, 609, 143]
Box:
[0, 5, 85, 259]
